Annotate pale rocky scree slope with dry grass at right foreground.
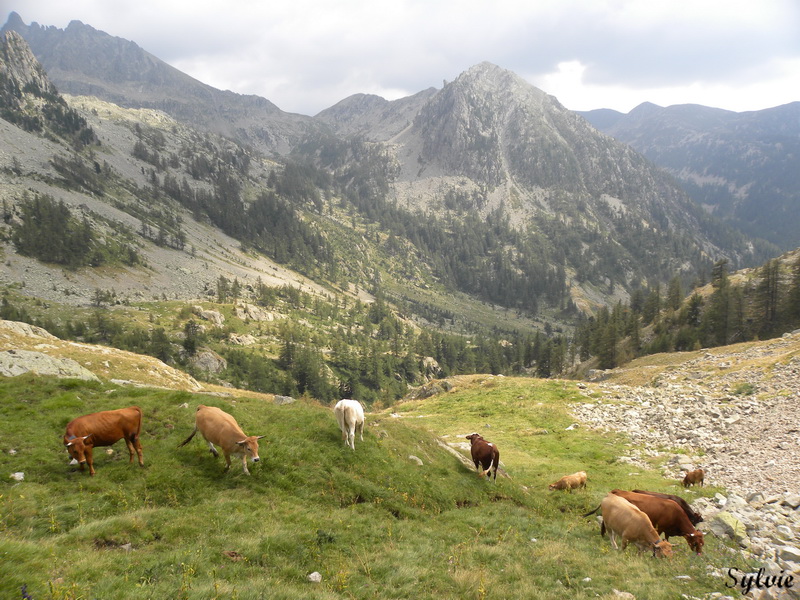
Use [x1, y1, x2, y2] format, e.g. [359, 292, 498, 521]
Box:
[573, 331, 800, 584]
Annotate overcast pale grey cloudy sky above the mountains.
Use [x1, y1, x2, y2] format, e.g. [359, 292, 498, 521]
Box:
[2, 0, 800, 115]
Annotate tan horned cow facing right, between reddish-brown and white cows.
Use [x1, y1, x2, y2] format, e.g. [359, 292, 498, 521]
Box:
[178, 404, 266, 475]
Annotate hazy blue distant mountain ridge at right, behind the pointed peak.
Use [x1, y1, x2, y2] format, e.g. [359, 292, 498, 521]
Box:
[581, 102, 800, 250]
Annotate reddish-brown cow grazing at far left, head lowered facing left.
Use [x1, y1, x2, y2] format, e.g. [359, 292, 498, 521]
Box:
[64, 406, 144, 475]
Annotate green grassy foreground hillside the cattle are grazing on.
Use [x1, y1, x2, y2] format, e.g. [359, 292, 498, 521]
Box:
[0, 376, 742, 600]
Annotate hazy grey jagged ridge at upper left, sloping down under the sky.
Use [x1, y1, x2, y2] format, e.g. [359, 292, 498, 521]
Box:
[2, 12, 318, 154]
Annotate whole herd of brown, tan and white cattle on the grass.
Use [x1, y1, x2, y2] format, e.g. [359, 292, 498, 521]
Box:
[64, 400, 705, 557]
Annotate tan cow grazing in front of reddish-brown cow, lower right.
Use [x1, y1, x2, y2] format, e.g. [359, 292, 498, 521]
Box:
[584, 493, 672, 558]
